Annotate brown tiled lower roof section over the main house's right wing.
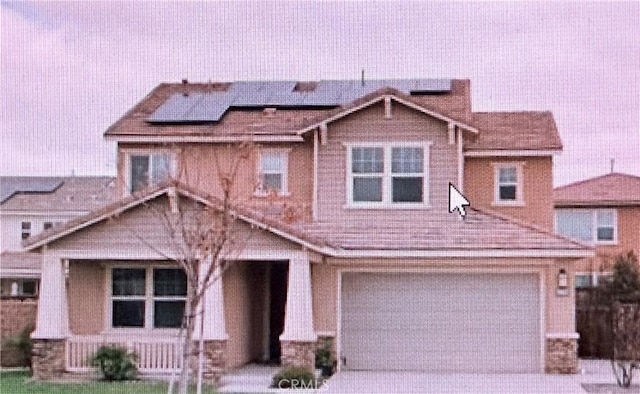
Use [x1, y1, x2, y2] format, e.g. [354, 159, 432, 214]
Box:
[464, 111, 562, 156]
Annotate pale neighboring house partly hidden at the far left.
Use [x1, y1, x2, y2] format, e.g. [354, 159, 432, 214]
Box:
[0, 176, 115, 297]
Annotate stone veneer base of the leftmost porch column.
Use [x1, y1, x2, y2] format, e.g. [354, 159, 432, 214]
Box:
[31, 339, 66, 380]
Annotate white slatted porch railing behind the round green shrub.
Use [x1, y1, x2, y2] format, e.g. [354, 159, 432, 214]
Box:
[66, 336, 182, 374]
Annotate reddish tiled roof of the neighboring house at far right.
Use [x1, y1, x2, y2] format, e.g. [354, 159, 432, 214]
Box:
[553, 173, 640, 207]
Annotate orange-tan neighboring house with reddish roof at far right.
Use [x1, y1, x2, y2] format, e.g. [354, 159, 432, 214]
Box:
[553, 173, 640, 287]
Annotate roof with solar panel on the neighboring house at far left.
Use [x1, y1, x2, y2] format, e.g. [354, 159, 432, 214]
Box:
[0, 176, 116, 213]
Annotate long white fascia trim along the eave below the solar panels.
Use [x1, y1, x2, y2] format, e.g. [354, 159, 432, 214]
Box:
[105, 134, 304, 144]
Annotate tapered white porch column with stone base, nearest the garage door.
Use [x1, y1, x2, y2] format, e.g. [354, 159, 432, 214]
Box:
[280, 254, 318, 368]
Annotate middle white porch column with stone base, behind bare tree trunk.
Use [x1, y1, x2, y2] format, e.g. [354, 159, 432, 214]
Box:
[194, 261, 228, 385]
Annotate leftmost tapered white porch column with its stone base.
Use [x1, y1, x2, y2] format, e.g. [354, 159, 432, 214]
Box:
[31, 254, 69, 380]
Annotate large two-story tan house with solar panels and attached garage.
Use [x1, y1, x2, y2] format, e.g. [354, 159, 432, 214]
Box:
[26, 80, 593, 380]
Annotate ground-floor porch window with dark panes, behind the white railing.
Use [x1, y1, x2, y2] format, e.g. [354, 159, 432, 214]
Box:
[111, 268, 187, 328]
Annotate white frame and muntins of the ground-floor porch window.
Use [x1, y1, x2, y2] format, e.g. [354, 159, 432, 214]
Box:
[103, 263, 189, 333]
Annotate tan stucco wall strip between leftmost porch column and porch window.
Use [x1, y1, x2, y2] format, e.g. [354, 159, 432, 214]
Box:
[67, 261, 108, 335]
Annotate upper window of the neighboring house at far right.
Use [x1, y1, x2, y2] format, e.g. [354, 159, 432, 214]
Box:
[556, 209, 618, 244]
